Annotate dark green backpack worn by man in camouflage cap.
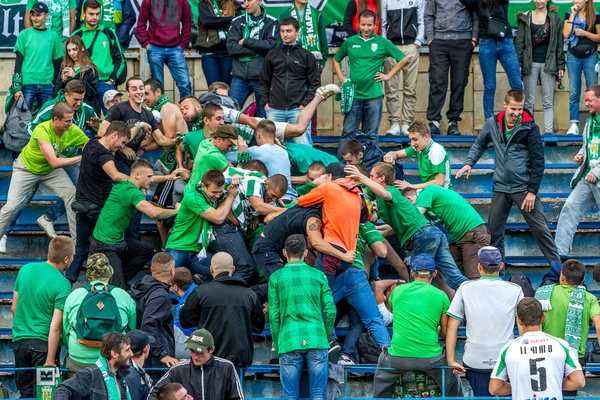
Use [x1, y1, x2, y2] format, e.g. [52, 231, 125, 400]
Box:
[75, 283, 122, 349]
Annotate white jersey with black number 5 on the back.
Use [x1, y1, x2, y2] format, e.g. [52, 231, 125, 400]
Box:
[491, 331, 581, 400]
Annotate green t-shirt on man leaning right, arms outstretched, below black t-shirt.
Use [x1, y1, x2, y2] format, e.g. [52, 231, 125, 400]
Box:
[93, 181, 146, 244]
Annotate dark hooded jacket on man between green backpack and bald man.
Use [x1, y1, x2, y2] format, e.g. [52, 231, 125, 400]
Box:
[131, 275, 175, 368]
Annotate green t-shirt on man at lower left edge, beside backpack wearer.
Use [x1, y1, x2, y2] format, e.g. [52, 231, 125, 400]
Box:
[12, 262, 71, 342]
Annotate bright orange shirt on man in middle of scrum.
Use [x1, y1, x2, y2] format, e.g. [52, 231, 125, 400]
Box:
[298, 178, 361, 251]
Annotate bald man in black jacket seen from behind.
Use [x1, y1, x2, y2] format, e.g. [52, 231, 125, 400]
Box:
[179, 252, 265, 368]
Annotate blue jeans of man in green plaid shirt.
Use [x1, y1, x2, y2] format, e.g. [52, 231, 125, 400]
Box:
[279, 349, 329, 400]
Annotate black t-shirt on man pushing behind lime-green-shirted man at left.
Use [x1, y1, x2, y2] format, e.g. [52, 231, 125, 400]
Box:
[75, 138, 115, 207]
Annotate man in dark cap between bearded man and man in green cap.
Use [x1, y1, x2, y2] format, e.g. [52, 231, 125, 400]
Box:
[125, 329, 156, 400]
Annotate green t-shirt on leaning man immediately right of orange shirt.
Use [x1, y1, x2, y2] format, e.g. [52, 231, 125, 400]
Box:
[367, 186, 429, 245]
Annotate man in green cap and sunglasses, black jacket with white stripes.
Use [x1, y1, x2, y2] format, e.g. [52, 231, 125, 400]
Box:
[148, 329, 244, 400]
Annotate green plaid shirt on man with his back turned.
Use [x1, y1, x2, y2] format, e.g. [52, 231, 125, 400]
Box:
[269, 261, 336, 354]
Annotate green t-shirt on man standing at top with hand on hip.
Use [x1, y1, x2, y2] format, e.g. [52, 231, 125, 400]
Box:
[333, 34, 404, 100]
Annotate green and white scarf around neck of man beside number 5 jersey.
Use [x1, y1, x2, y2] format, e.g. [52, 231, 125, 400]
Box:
[535, 285, 587, 350]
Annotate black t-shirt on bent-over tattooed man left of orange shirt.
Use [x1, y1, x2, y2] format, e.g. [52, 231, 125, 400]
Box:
[263, 206, 321, 249]
